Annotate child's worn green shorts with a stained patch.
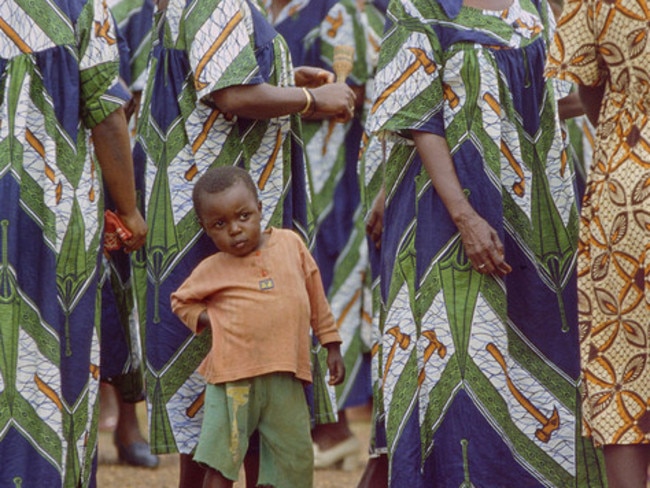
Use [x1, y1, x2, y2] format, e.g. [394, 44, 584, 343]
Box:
[194, 373, 314, 488]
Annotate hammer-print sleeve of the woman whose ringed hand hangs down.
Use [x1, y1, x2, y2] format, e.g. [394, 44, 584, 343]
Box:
[368, 2, 444, 143]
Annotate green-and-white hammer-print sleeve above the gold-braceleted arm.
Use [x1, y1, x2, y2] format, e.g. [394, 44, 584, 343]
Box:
[185, 0, 264, 99]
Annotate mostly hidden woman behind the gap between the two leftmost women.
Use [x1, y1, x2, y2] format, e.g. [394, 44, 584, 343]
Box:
[99, 0, 159, 467]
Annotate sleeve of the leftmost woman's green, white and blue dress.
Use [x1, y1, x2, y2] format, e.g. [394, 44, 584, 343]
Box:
[77, 0, 131, 128]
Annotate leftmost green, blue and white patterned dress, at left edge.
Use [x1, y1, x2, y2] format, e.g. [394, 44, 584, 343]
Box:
[0, 0, 128, 487]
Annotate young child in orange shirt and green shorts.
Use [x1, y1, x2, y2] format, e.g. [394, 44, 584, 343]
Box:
[171, 166, 345, 488]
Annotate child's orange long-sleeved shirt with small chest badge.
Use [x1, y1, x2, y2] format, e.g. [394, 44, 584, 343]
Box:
[171, 228, 341, 383]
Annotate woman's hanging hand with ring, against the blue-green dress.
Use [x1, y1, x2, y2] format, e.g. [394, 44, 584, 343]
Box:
[456, 212, 512, 276]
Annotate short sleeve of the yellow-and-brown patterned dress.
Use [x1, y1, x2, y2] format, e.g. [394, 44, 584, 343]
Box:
[545, 0, 607, 86]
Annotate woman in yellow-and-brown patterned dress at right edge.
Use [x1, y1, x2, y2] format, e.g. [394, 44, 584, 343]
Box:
[547, 0, 650, 488]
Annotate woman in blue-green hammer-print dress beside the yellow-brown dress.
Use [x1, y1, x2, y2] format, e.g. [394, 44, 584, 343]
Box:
[362, 0, 602, 488]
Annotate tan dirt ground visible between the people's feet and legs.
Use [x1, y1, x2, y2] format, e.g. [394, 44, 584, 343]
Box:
[97, 404, 370, 488]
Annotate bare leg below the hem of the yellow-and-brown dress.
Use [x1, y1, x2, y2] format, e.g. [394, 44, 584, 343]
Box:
[604, 444, 650, 488]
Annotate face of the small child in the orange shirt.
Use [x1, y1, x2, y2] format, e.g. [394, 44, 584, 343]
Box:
[200, 180, 262, 257]
